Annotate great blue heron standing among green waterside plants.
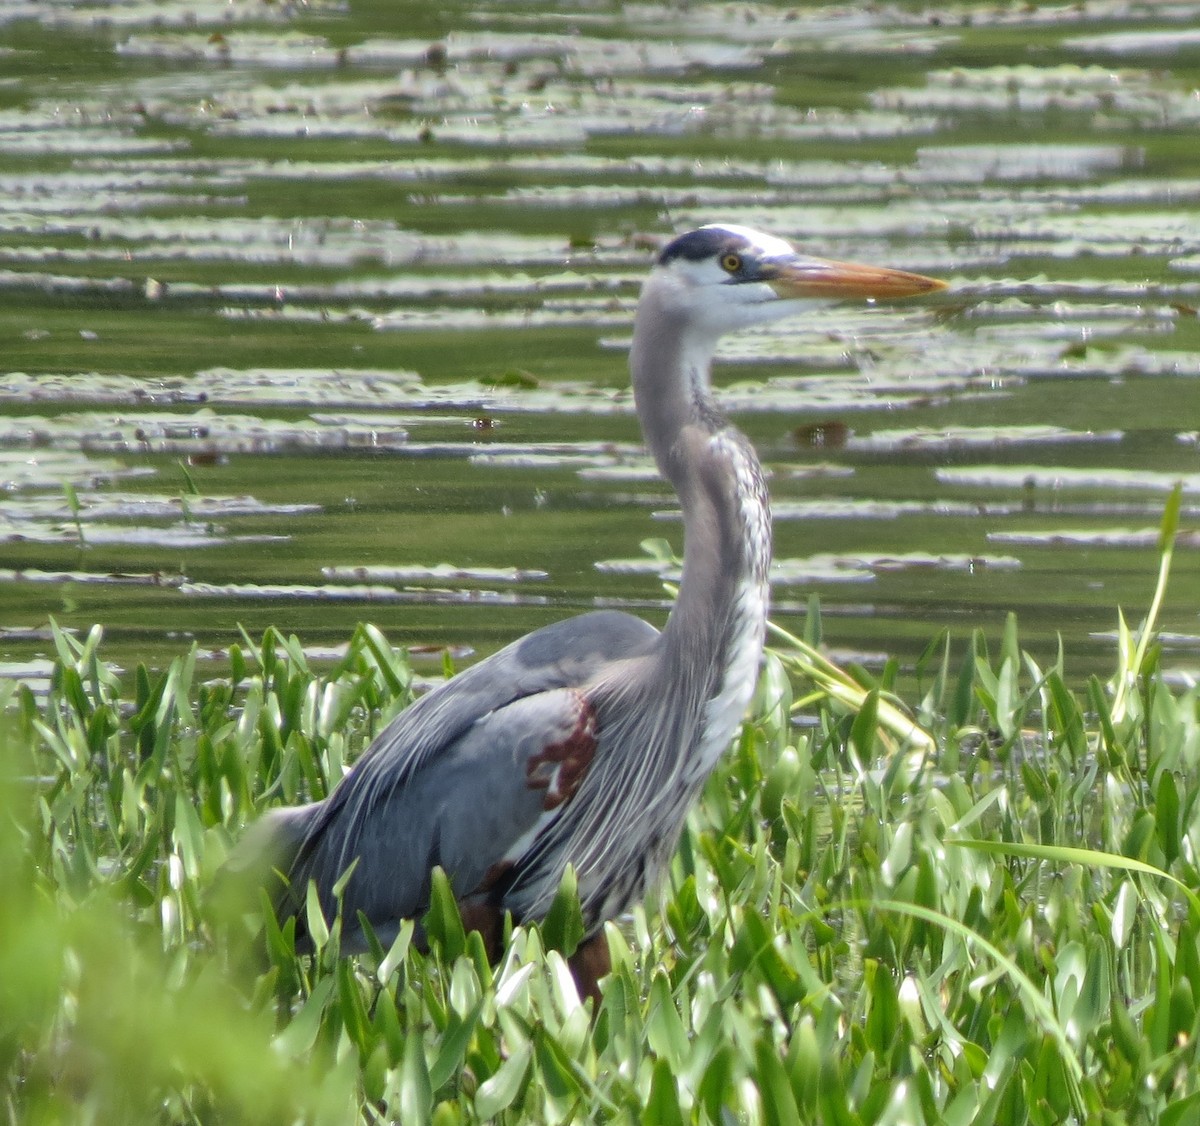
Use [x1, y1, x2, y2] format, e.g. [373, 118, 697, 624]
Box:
[250, 226, 943, 998]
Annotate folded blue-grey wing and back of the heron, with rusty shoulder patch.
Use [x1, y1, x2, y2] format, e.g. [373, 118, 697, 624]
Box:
[256, 611, 659, 923]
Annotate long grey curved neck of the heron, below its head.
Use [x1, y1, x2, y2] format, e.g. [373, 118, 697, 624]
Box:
[630, 285, 770, 693]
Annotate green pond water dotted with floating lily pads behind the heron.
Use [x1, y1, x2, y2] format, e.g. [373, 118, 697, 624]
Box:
[0, 0, 1200, 682]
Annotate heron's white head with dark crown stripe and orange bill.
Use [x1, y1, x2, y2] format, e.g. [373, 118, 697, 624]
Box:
[649, 223, 946, 336]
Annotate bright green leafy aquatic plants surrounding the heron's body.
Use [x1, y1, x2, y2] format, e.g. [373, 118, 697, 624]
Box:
[0, 516, 1200, 1124]
